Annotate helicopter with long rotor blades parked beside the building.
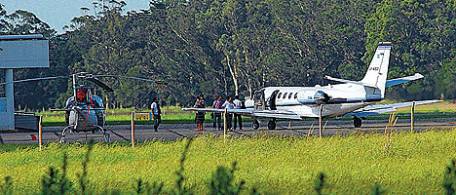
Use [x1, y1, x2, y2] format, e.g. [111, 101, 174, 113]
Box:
[0, 72, 161, 143]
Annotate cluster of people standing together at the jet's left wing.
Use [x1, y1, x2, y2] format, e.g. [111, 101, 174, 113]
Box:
[194, 96, 245, 132]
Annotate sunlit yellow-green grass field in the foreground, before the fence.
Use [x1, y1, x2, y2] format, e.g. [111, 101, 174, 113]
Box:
[0, 130, 456, 194]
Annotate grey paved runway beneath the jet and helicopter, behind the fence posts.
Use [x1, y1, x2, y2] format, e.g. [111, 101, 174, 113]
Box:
[0, 118, 456, 144]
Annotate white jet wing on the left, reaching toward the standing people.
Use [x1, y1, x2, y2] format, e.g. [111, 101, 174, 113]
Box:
[182, 108, 302, 120]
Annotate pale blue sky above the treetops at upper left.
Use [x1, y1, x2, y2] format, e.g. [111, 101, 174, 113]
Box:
[0, 0, 149, 32]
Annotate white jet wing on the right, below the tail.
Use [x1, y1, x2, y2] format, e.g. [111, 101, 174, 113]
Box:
[345, 100, 441, 117]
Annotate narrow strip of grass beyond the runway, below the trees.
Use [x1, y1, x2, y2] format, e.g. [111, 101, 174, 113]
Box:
[37, 102, 456, 126]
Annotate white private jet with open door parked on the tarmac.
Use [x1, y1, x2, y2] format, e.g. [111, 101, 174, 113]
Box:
[183, 42, 438, 130]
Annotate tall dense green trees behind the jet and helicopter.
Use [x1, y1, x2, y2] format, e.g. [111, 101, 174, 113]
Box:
[0, 0, 456, 109]
